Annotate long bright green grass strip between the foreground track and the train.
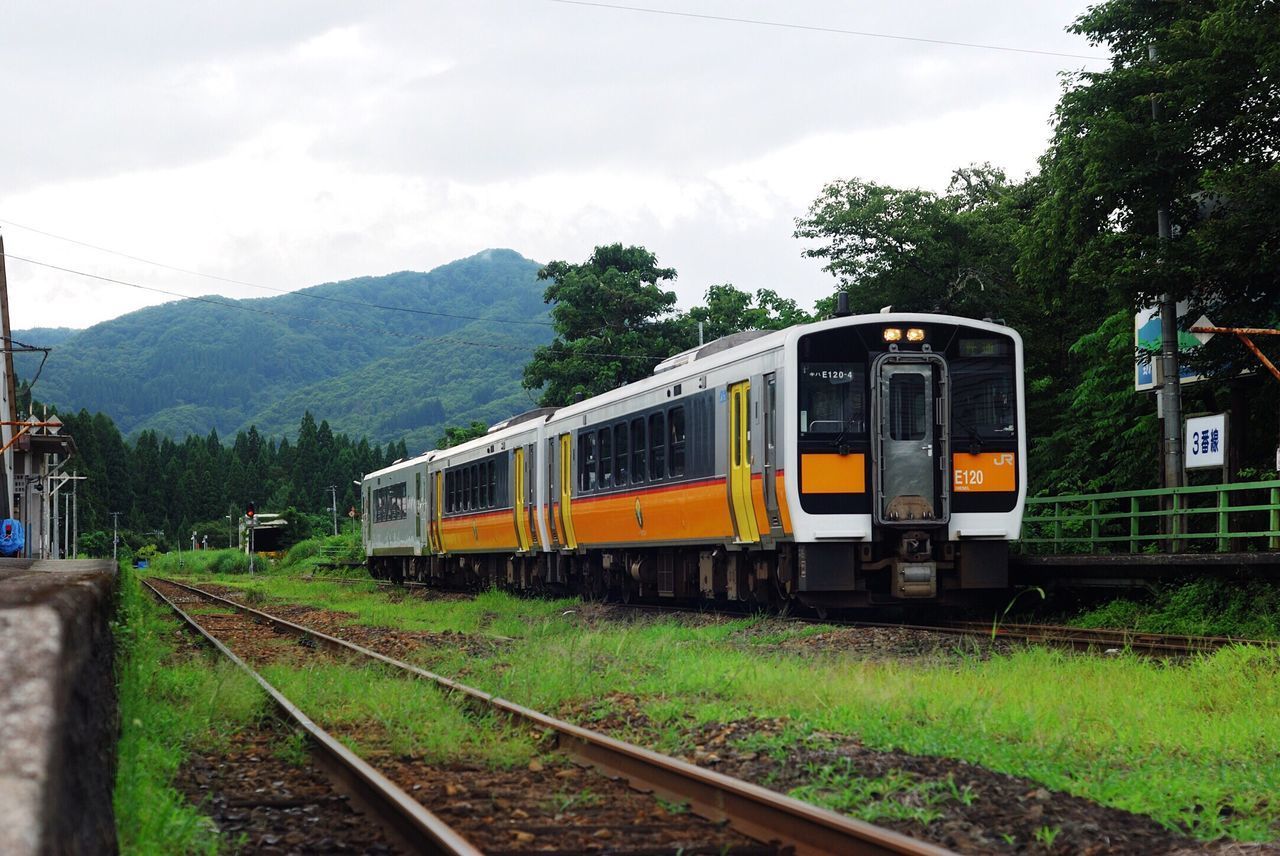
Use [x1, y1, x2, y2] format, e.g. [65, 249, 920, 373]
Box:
[165, 577, 1280, 841]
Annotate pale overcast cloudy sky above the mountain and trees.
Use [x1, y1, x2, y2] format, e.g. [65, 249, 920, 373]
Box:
[0, 0, 1103, 329]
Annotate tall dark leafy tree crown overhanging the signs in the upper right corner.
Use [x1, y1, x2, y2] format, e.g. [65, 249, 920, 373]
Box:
[1025, 0, 1280, 326]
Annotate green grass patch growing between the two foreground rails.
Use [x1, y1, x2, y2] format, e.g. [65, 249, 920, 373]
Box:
[262, 665, 536, 768]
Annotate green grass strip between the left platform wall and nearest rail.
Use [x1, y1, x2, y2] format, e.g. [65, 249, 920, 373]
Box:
[114, 569, 264, 853]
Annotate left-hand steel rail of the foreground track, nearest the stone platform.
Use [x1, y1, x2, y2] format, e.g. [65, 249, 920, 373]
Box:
[142, 580, 481, 856]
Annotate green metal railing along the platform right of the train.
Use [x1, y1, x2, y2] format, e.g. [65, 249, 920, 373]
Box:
[1020, 480, 1280, 554]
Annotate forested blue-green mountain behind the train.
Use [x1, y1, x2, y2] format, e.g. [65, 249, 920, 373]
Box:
[14, 250, 552, 450]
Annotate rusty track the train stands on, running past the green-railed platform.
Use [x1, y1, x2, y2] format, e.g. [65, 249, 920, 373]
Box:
[293, 576, 1280, 656]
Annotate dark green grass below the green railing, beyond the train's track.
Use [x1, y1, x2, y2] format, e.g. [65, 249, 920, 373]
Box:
[1071, 580, 1280, 640]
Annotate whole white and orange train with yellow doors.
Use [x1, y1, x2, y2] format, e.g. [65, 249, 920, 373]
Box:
[361, 310, 1027, 606]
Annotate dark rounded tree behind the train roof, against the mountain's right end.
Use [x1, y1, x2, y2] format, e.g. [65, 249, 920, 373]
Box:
[524, 243, 681, 407]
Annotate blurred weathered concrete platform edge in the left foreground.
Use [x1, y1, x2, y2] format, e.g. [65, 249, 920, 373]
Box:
[0, 559, 119, 855]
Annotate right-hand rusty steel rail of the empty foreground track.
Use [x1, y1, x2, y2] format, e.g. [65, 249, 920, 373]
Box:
[152, 580, 952, 856]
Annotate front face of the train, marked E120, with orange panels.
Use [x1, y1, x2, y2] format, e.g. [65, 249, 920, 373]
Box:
[785, 313, 1027, 608]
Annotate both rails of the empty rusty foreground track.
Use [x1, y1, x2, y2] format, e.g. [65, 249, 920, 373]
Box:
[146, 580, 950, 855]
